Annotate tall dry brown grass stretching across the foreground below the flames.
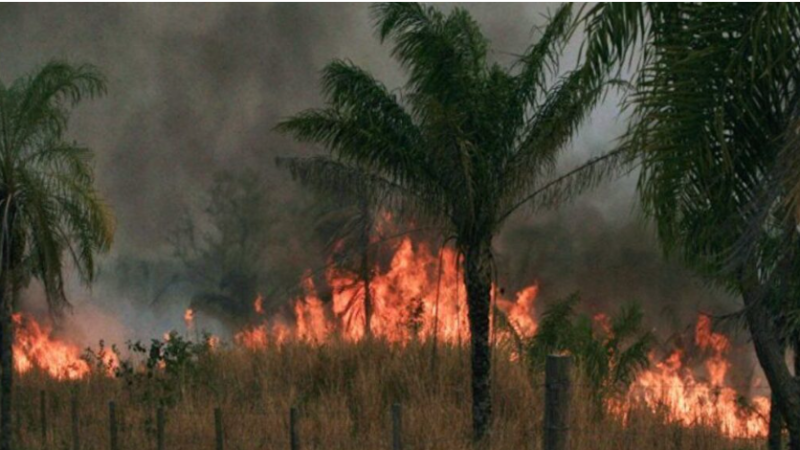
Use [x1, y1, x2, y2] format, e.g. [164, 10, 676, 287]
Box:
[15, 342, 760, 450]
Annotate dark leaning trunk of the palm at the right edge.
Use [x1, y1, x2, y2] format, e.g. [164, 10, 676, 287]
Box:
[742, 282, 800, 450]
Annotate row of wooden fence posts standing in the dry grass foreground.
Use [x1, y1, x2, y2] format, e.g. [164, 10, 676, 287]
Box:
[20, 355, 572, 450]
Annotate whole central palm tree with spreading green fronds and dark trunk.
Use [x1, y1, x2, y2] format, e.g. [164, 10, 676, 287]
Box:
[279, 3, 614, 441]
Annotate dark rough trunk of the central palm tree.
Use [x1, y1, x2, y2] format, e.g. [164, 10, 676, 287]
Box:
[463, 241, 492, 442]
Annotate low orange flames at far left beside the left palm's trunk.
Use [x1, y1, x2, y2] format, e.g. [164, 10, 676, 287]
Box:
[13, 313, 117, 380]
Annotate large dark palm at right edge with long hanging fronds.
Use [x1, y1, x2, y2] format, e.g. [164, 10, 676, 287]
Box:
[586, 3, 800, 450]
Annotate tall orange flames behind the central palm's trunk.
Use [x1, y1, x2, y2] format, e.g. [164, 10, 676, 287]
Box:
[235, 238, 538, 348]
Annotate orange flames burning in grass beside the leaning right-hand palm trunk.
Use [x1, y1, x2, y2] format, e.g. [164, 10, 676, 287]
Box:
[610, 316, 770, 438]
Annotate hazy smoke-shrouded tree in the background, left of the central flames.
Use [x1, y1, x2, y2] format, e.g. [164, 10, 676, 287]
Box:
[170, 171, 271, 322]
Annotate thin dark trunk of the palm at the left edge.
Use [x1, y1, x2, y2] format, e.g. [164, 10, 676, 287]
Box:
[0, 276, 14, 450]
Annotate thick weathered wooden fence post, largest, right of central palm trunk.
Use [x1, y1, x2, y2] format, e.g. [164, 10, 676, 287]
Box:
[543, 355, 572, 450]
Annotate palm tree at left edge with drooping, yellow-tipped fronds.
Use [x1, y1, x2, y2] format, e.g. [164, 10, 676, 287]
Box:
[0, 62, 113, 450]
